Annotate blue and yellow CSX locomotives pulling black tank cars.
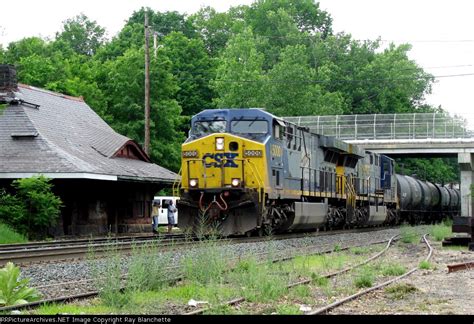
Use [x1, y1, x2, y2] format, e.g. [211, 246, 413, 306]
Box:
[178, 109, 459, 235]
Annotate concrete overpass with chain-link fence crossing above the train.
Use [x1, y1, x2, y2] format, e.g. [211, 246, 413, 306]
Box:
[285, 113, 474, 216]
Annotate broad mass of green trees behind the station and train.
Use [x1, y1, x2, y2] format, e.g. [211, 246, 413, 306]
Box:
[0, 0, 440, 177]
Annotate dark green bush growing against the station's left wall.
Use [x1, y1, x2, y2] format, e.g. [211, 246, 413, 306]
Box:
[0, 175, 62, 238]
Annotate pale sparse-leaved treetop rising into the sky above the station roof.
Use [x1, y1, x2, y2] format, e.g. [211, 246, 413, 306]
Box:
[56, 13, 105, 56]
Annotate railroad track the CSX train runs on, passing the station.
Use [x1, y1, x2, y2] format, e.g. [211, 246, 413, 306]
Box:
[0, 227, 396, 266]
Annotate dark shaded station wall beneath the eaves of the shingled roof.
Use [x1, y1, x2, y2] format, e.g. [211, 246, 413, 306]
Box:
[0, 179, 163, 236]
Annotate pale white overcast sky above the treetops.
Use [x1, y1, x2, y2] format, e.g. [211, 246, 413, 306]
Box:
[0, 0, 474, 124]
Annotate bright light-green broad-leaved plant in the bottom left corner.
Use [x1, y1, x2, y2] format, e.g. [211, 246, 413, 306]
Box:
[0, 262, 40, 306]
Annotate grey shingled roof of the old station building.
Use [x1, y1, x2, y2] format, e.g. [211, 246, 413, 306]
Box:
[0, 85, 177, 183]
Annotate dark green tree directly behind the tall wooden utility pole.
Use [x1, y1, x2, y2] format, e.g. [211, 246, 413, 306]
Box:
[104, 49, 184, 171]
